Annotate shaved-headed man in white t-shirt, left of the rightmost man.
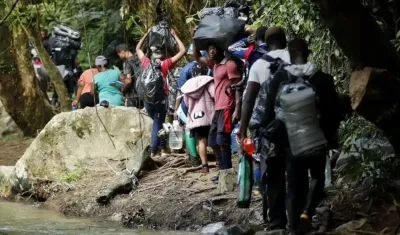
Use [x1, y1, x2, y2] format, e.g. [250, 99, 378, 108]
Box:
[239, 27, 290, 230]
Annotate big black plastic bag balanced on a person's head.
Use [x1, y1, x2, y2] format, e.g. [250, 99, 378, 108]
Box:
[193, 15, 246, 50]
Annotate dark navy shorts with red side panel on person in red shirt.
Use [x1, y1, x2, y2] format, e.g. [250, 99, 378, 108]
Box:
[208, 109, 234, 147]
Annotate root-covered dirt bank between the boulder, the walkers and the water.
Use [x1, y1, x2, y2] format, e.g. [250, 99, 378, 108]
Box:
[45, 157, 262, 231]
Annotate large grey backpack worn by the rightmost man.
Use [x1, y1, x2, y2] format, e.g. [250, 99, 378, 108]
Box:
[275, 72, 327, 157]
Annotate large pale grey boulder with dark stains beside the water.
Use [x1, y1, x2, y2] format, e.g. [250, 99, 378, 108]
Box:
[3, 107, 152, 195]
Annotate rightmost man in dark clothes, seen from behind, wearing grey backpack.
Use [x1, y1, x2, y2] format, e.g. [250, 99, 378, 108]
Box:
[264, 39, 341, 235]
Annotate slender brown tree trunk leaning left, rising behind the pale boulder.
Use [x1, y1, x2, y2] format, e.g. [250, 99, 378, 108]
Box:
[25, 28, 71, 112]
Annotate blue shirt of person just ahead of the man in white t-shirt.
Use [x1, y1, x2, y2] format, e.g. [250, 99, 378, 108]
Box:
[228, 38, 268, 70]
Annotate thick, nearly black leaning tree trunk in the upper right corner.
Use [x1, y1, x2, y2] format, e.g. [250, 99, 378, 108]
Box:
[318, 0, 400, 76]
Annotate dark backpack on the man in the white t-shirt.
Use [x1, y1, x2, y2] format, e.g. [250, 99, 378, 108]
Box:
[249, 55, 288, 130]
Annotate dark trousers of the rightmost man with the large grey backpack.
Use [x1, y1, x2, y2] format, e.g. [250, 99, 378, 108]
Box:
[285, 149, 326, 234]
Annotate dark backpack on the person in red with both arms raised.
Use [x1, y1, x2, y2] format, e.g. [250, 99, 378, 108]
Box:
[137, 61, 164, 104]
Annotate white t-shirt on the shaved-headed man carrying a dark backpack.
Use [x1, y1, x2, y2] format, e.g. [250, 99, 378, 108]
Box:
[248, 49, 290, 84]
